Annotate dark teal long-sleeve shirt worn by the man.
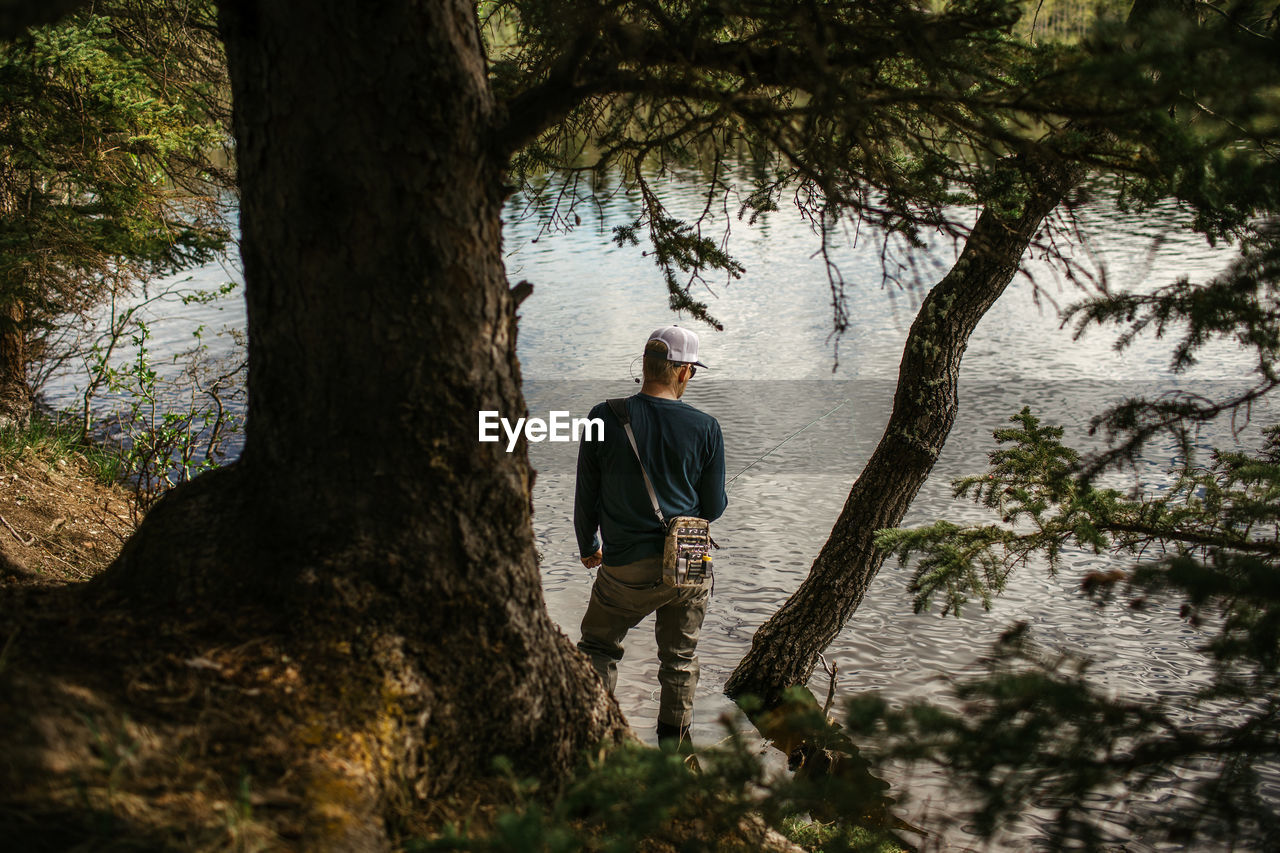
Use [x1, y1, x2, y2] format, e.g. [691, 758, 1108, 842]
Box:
[573, 393, 727, 566]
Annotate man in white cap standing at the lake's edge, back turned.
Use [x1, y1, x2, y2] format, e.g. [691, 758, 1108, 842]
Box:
[573, 325, 727, 744]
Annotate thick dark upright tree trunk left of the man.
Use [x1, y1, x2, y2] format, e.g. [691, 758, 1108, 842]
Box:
[105, 0, 626, 849]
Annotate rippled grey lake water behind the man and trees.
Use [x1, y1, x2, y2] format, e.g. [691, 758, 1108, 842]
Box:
[47, 175, 1268, 849]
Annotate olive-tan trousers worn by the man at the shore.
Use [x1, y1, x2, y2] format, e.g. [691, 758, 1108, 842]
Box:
[577, 557, 708, 726]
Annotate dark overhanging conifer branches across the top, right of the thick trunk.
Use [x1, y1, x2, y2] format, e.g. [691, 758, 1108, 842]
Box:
[480, 0, 1280, 345]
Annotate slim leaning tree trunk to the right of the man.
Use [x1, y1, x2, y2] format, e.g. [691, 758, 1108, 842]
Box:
[724, 153, 1082, 707]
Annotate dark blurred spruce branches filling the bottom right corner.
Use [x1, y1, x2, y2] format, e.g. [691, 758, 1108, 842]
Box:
[849, 625, 1280, 849]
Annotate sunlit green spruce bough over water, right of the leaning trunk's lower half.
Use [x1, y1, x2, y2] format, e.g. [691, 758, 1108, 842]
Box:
[877, 409, 1280, 613]
